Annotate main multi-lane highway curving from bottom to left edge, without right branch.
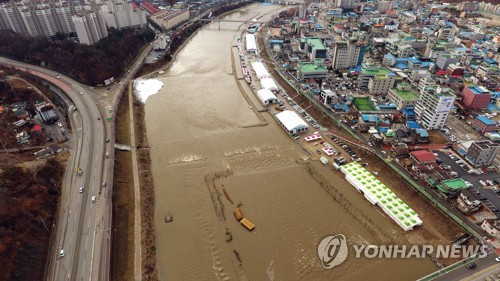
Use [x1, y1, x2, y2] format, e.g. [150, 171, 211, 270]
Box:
[0, 58, 108, 280]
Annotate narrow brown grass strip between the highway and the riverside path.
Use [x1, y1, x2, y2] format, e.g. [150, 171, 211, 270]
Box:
[111, 95, 134, 281]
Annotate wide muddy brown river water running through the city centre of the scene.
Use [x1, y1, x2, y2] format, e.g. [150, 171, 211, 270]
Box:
[145, 4, 435, 280]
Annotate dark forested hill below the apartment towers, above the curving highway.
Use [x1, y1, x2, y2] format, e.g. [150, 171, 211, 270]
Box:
[0, 29, 154, 86]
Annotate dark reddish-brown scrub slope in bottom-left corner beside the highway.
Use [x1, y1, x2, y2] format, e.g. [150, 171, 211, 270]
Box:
[0, 154, 68, 280]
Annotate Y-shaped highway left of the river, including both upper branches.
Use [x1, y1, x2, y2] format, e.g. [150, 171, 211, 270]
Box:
[0, 42, 152, 280]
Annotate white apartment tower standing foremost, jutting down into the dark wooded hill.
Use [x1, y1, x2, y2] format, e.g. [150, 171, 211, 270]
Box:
[71, 12, 108, 45]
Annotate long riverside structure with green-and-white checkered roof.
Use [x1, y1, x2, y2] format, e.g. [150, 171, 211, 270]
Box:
[340, 162, 422, 231]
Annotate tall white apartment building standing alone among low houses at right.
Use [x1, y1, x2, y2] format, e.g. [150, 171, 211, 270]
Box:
[415, 86, 456, 130]
